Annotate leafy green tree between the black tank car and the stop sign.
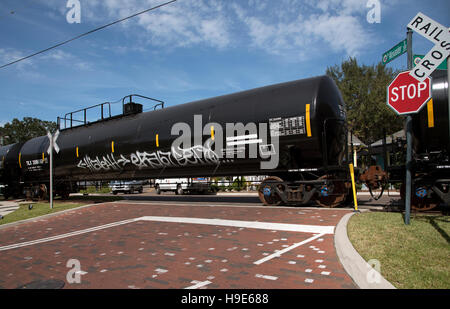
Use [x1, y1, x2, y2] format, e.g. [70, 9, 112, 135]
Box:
[327, 58, 403, 144]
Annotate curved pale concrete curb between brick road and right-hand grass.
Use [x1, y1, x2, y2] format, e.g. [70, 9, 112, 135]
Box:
[334, 213, 395, 289]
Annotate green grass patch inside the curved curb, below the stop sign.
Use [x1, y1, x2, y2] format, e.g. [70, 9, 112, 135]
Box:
[347, 212, 450, 289]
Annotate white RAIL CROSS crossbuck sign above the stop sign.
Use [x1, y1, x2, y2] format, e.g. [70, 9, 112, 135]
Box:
[408, 12, 450, 82]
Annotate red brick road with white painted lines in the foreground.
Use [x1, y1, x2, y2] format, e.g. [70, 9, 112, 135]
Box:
[0, 202, 356, 289]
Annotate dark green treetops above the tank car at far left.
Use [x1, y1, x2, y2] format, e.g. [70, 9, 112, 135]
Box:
[0, 117, 57, 145]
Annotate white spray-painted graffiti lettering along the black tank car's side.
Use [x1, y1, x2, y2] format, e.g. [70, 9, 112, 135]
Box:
[77, 142, 219, 172]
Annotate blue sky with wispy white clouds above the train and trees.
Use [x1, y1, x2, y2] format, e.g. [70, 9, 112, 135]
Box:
[0, 0, 450, 125]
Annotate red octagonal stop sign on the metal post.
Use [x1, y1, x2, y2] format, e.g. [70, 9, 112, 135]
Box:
[387, 71, 431, 115]
